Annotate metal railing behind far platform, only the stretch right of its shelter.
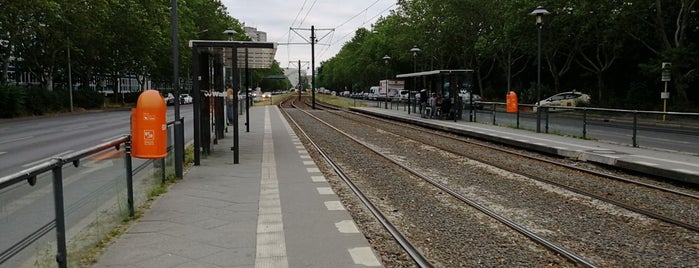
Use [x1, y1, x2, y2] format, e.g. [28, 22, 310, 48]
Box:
[471, 102, 699, 153]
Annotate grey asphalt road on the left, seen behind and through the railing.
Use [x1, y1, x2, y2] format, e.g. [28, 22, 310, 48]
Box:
[0, 105, 193, 267]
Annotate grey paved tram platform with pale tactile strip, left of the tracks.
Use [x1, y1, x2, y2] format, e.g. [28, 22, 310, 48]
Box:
[92, 106, 381, 268]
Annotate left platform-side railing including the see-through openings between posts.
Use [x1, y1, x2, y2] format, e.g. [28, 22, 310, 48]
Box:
[0, 118, 183, 267]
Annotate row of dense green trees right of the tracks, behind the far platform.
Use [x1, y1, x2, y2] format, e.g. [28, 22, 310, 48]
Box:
[319, 0, 699, 111]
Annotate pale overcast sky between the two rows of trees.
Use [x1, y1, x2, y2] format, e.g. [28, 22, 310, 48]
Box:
[221, 0, 397, 69]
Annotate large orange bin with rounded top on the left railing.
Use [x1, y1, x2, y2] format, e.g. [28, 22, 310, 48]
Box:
[131, 89, 167, 159]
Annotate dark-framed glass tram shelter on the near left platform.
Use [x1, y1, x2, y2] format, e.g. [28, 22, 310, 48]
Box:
[189, 40, 277, 165]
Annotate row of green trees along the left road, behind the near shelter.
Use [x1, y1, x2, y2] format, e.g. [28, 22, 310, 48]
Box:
[0, 0, 286, 102]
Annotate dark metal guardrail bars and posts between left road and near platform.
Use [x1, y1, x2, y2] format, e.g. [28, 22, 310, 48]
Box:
[0, 118, 184, 268]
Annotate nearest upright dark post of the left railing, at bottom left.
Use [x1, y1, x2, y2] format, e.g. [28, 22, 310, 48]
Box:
[53, 160, 68, 268]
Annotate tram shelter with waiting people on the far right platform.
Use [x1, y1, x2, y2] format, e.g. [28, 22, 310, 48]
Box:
[396, 69, 473, 121]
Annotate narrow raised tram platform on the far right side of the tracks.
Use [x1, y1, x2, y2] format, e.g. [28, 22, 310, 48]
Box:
[350, 107, 699, 184]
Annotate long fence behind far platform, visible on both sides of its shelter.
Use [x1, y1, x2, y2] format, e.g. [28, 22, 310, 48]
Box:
[370, 99, 699, 154]
